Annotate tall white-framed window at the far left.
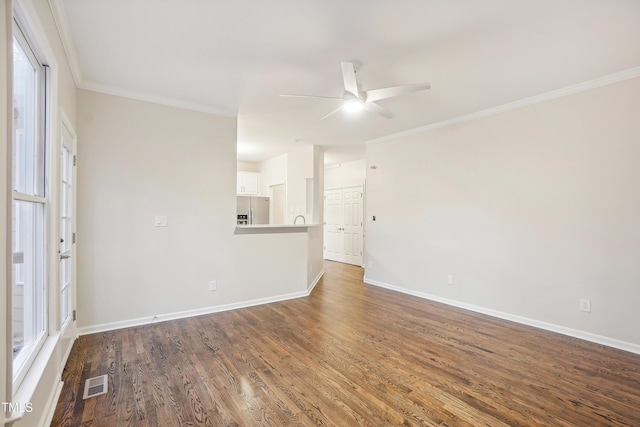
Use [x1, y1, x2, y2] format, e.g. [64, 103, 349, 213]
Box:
[11, 19, 48, 385]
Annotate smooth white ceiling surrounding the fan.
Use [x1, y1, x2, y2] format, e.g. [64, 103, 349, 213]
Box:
[52, 0, 640, 163]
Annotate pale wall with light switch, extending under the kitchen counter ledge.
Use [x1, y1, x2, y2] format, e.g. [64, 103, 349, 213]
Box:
[78, 90, 318, 333]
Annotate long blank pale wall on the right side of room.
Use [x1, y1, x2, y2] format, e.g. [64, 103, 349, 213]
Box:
[366, 78, 640, 351]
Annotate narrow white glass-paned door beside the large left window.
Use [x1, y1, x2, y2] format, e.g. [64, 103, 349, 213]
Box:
[59, 121, 76, 345]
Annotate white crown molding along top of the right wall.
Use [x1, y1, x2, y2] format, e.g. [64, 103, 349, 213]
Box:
[365, 67, 640, 144]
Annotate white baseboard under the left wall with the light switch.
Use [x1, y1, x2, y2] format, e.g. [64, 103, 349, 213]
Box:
[77, 291, 310, 336]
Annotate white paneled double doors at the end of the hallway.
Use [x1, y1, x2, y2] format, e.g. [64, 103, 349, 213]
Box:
[324, 186, 364, 265]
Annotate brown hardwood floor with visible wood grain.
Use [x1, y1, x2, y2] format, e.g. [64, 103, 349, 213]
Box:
[52, 262, 640, 427]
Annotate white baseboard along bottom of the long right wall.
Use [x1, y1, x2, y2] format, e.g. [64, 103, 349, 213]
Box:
[363, 273, 640, 354]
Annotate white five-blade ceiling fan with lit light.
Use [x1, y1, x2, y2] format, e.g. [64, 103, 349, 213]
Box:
[280, 62, 431, 120]
